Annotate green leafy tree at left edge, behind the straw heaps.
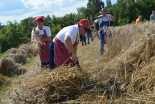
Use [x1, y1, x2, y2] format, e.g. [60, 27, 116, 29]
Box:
[0, 21, 29, 52]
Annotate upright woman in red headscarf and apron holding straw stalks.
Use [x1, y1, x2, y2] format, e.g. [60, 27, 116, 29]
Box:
[31, 16, 51, 68]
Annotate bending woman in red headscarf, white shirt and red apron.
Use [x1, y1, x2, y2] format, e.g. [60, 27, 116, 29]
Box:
[49, 19, 91, 70]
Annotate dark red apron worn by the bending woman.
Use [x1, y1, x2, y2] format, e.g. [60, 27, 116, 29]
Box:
[54, 36, 78, 66]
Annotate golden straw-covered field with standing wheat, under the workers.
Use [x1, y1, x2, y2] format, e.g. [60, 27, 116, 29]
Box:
[1, 22, 155, 104]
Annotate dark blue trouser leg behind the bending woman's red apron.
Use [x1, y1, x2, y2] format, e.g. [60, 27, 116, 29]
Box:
[49, 41, 56, 71]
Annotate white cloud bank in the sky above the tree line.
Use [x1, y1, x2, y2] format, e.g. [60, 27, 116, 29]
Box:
[0, 0, 94, 25]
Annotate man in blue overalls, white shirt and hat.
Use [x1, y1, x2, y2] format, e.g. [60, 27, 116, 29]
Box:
[94, 8, 115, 55]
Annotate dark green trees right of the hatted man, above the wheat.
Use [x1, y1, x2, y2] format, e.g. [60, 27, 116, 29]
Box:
[108, 0, 155, 25]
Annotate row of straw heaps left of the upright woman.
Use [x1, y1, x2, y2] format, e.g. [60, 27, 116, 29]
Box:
[0, 43, 37, 76]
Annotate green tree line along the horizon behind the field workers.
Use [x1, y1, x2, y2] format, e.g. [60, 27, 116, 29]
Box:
[0, 0, 155, 52]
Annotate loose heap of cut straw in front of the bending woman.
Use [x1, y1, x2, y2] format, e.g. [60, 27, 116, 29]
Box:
[5, 67, 92, 104]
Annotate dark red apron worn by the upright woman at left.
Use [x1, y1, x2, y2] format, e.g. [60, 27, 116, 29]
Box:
[39, 30, 50, 63]
